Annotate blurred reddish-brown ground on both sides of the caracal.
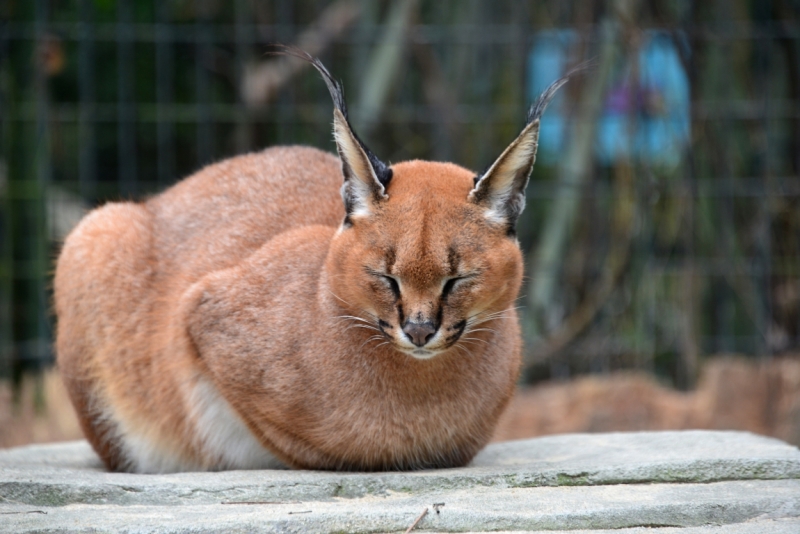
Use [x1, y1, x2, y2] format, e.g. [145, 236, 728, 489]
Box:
[0, 358, 800, 447]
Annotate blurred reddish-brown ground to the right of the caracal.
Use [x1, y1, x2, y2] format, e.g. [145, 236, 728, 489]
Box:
[494, 358, 800, 445]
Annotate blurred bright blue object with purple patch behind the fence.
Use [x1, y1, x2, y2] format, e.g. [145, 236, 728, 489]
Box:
[528, 30, 690, 166]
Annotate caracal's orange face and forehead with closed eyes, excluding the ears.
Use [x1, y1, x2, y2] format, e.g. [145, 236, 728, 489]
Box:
[328, 161, 522, 359]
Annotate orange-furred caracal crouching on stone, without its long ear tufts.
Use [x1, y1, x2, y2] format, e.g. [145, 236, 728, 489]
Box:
[55, 53, 568, 472]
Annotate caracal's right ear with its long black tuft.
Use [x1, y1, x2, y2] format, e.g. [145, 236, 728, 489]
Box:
[467, 66, 585, 235]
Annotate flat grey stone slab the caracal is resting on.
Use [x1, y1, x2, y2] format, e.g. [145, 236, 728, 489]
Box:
[0, 431, 800, 534]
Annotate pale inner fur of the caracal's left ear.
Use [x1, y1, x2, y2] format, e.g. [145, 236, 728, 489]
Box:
[333, 109, 388, 217]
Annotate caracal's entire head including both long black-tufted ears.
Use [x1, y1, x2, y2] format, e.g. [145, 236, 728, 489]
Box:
[287, 49, 567, 359]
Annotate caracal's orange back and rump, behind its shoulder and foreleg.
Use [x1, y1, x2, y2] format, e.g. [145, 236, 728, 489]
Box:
[54, 147, 344, 471]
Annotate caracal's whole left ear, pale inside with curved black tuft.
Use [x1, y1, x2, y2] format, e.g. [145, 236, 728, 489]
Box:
[279, 46, 392, 225]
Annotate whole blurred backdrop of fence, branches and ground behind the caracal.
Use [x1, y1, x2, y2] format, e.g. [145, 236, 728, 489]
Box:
[0, 0, 800, 446]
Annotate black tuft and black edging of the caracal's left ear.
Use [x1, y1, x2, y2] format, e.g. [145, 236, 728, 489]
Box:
[272, 44, 392, 197]
